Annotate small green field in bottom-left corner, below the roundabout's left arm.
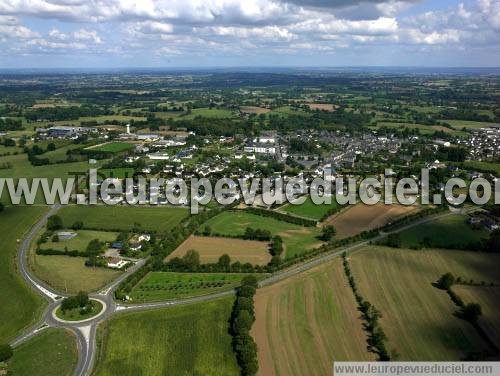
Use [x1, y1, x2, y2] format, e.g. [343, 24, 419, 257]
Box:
[7, 329, 78, 376]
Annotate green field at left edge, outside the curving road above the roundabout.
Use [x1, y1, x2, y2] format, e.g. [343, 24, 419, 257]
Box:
[0, 206, 45, 343]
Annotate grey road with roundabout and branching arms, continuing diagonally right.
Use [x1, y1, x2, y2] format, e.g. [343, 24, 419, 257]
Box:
[11, 204, 468, 376]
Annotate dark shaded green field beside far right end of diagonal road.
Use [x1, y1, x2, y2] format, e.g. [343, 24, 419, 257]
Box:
[400, 215, 488, 248]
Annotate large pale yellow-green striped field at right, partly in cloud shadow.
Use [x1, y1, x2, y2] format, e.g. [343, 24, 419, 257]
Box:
[350, 246, 500, 361]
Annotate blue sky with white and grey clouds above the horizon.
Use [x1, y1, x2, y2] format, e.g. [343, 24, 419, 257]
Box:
[0, 0, 500, 68]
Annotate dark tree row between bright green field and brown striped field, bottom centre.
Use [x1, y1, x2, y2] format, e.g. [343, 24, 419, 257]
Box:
[231, 276, 259, 376]
